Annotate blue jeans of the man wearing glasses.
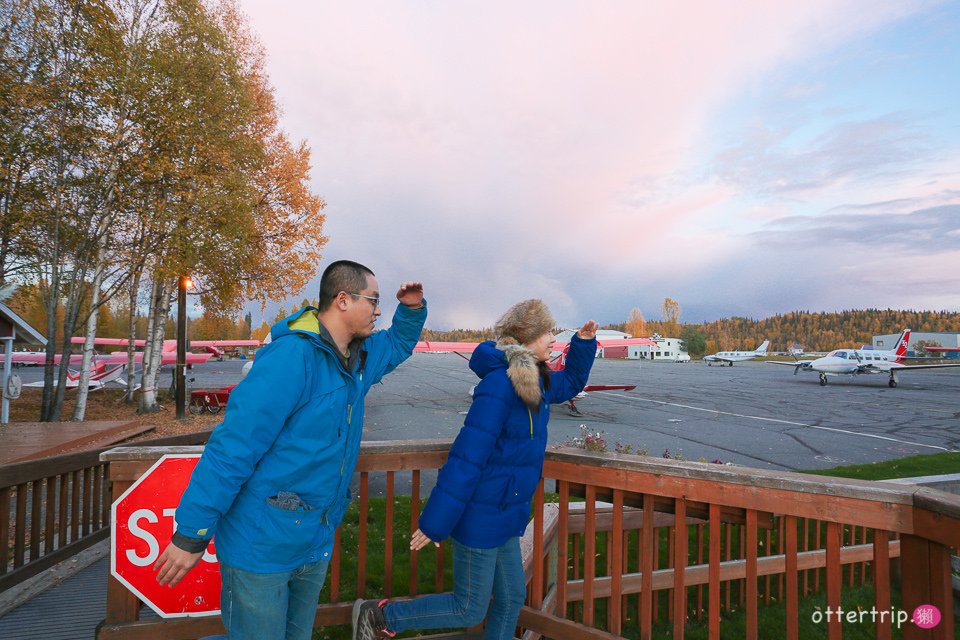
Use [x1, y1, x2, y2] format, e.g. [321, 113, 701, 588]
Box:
[220, 560, 329, 640]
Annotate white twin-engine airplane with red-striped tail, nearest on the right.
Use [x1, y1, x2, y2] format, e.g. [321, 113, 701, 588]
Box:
[770, 329, 960, 388]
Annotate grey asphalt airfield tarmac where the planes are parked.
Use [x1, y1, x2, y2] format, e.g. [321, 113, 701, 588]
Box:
[18, 353, 960, 470]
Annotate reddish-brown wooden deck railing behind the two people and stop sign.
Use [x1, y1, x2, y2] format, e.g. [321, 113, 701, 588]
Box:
[97, 441, 960, 640]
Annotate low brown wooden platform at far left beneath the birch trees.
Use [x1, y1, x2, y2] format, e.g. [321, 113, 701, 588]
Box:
[0, 420, 154, 464]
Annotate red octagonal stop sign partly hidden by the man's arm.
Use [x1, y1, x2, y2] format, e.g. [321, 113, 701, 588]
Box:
[110, 454, 220, 618]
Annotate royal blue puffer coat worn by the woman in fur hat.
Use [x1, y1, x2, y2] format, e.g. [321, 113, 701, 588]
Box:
[420, 336, 597, 549]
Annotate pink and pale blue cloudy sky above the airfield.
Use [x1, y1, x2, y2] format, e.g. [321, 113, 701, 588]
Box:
[240, 0, 960, 330]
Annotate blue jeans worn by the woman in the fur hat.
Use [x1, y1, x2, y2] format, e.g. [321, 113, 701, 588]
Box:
[383, 538, 527, 640]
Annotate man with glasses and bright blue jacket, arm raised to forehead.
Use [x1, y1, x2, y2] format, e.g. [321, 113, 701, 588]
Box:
[154, 260, 427, 640]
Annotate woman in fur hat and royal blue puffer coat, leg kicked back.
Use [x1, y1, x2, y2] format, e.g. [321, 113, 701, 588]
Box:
[353, 299, 598, 640]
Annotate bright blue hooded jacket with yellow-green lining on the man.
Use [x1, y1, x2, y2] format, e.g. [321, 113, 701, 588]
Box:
[176, 303, 427, 573]
